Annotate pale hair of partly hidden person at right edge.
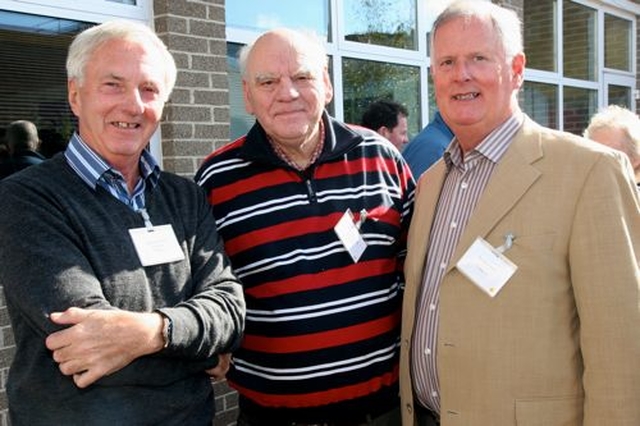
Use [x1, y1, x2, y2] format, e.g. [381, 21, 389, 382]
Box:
[583, 105, 640, 161]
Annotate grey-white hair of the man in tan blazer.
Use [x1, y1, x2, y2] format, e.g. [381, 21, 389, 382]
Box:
[430, 0, 524, 60]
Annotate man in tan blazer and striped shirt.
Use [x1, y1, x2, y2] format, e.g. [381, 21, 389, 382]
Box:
[400, 1, 640, 426]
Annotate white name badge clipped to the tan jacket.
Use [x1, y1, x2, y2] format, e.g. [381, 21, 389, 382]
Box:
[456, 237, 518, 297]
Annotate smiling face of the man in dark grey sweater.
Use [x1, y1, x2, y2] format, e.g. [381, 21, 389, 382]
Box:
[68, 39, 168, 173]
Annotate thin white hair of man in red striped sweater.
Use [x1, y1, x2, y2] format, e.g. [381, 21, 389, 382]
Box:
[238, 28, 329, 78]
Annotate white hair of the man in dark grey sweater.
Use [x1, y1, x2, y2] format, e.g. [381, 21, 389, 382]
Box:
[67, 20, 178, 97]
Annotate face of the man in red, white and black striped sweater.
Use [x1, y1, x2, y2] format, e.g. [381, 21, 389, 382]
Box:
[243, 31, 333, 149]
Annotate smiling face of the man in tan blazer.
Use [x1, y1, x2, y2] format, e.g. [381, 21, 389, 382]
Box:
[431, 17, 525, 151]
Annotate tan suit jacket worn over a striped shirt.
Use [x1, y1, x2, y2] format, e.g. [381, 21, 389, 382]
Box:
[400, 118, 640, 426]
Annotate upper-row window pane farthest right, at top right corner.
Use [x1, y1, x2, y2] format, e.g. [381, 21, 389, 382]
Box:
[604, 14, 631, 71]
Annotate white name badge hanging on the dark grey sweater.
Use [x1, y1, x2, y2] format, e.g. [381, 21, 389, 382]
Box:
[129, 225, 184, 266]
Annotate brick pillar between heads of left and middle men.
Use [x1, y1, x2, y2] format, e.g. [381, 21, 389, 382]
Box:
[154, 0, 229, 176]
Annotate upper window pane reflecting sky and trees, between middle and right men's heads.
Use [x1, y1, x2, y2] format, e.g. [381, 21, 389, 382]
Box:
[343, 0, 418, 50]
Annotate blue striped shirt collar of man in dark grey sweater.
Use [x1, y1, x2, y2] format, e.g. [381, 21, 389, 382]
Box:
[64, 133, 160, 189]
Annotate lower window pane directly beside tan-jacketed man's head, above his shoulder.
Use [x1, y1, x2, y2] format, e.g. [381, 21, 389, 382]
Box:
[519, 81, 558, 129]
